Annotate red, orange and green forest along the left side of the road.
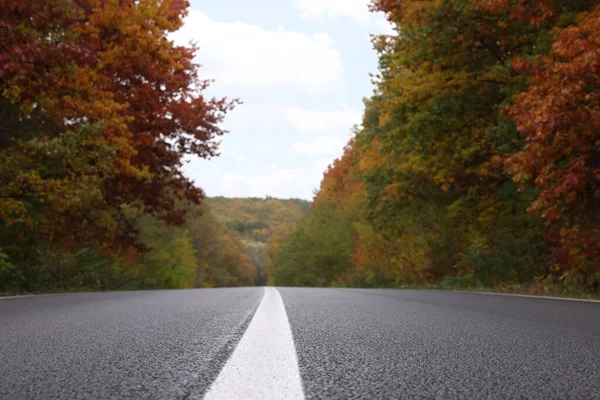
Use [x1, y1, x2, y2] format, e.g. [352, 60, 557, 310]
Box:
[0, 0, 256, 293]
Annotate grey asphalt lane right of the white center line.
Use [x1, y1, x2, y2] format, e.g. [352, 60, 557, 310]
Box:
[279, 288, 600, 400]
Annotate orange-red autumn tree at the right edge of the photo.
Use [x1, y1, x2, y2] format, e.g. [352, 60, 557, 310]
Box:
[506, 9, 600, 288]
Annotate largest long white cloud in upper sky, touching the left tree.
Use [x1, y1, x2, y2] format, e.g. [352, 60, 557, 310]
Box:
[170, 10, 342, 91]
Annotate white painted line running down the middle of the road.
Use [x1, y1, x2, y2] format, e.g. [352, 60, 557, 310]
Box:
[204, 287, 304, 400]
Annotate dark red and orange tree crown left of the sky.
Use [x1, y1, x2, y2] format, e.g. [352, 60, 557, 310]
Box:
[0, 0, 234, 250]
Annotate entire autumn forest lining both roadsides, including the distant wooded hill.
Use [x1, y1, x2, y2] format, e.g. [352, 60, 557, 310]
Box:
[0, 0, 600, 294]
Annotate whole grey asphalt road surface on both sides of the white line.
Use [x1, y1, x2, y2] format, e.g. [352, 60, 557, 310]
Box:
[0, 288, 600, 399]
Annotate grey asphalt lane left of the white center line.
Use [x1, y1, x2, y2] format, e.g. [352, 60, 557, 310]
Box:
[0, 288, 263, 400]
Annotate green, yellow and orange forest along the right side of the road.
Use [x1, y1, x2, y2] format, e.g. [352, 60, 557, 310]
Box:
[271, 0, 600, 294]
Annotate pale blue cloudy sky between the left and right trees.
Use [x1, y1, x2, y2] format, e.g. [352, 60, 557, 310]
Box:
[171, 0, 391, 200]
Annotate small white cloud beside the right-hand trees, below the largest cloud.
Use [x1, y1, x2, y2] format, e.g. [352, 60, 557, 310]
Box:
[283, 106, 362, 132]
